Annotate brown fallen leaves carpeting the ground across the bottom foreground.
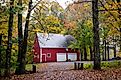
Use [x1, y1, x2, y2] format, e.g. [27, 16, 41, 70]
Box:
[11, 69, 121, 80]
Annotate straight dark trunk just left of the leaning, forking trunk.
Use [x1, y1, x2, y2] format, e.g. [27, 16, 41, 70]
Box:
[15, 0, 23, 74]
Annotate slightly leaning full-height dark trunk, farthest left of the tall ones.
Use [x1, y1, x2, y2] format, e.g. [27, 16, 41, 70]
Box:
[5, 0, 14, 76]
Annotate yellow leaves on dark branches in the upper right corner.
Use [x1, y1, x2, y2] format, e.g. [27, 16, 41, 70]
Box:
[100, 0, 120, 36]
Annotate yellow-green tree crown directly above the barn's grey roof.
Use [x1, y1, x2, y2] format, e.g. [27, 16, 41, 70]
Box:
[32, 1, 63, 33]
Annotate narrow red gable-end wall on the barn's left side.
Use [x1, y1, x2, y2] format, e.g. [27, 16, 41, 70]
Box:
[33, 35, 40, 63]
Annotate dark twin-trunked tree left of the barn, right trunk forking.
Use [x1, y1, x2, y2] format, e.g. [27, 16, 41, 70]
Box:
[16, 0, 41, 74]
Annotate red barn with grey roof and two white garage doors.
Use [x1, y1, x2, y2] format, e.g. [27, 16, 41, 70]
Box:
[33, 33, 79, 63]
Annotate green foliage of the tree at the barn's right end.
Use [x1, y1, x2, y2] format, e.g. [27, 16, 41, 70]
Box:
[69, 19, 93, 49]
